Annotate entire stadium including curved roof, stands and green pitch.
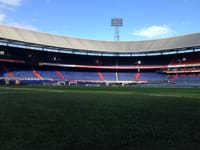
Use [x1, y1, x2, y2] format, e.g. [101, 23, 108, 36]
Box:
[0, 25, 200, 150]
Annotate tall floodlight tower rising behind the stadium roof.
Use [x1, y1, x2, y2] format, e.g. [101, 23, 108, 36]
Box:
[111, 18, 123, 41]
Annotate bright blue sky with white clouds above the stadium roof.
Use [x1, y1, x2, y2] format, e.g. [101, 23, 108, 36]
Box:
[0, 0, 200, 41]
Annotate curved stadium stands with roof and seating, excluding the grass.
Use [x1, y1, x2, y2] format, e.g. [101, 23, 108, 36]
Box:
[0, 25, 200, 86]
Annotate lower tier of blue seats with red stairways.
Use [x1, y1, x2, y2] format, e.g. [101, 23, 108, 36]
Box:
[0, 67, 200, 81]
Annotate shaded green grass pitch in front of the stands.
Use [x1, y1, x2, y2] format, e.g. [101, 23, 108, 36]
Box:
[0, 86, 200, 150]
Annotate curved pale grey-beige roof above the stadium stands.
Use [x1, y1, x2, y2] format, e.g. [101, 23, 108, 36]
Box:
[0, 25, 200, 53]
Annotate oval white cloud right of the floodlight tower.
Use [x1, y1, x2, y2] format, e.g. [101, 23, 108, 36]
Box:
[133, 25, 174, 39]
